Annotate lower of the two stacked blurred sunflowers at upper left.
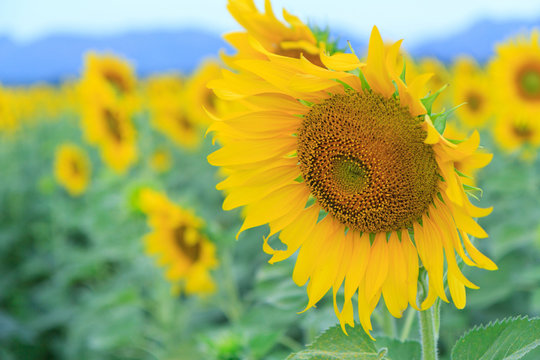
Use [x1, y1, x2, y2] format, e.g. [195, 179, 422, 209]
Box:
[82, 93, 137, 173]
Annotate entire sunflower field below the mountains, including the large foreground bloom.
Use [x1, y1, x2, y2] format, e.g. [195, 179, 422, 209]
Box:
[0, 0, 540, 360]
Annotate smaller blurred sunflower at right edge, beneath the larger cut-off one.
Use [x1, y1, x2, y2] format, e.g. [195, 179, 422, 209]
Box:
[494, 111, 540, 160]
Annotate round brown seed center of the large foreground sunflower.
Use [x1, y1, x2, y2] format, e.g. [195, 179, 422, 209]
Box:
[297, 92, 438, 232]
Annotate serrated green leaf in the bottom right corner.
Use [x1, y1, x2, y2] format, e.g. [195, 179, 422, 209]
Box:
[452, 317, 540, 360]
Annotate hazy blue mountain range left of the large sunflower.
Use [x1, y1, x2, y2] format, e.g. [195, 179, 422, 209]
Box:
[0, 30, 228, 85]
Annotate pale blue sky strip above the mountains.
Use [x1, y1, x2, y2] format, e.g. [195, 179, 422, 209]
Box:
[0, 0, 540, 44]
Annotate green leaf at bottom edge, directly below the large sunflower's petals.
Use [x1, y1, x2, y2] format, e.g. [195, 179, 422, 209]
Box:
[287, 324, 422, 360]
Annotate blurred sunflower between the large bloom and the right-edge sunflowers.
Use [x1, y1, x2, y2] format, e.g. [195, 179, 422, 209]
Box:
[452, 58, 493, 129]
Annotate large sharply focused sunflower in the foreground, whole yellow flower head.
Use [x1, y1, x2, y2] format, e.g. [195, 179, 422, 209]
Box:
[208, 28, 496, 333]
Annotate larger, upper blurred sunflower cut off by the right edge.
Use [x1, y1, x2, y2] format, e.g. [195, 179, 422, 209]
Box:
[489, 30, 540, 114]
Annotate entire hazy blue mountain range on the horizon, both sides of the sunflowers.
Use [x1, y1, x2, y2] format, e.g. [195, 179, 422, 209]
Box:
[0, 17, 540, 85]
